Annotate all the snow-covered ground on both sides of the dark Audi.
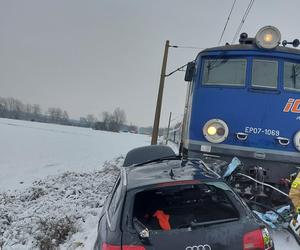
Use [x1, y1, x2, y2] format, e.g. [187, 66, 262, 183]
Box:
[0, 119, 299, 250]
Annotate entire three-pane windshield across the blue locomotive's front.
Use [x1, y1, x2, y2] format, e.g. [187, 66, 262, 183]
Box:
[202, 58, 282, 89]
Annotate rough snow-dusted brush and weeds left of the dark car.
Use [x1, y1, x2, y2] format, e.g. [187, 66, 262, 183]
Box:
[0, 157, 123, 250]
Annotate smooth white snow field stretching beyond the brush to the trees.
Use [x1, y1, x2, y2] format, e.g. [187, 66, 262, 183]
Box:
[0, 118, 150, 191]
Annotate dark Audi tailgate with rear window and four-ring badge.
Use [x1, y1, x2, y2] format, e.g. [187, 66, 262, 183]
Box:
[123, 183, 257, 250]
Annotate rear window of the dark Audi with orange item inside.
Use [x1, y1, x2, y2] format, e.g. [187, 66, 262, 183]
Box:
[132, 183, 239, 230]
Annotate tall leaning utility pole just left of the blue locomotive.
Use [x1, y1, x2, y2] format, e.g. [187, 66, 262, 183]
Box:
[151, 40, 170, 145]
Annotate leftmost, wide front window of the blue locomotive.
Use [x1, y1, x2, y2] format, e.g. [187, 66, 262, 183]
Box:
[202, 58, 247, 86]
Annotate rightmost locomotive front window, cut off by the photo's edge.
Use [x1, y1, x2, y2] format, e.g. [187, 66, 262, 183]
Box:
[283, 62, 300, 90]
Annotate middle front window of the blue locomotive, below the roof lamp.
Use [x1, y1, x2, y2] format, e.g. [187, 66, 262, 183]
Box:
[252, 59, 278, 89]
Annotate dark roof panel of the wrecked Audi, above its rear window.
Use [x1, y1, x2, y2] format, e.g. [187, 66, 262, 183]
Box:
[125, 160, 219, 189]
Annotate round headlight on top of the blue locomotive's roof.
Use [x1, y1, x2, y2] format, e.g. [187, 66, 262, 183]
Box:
[255, 26, 281, 49]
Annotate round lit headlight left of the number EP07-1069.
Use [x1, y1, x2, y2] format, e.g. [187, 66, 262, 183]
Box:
[203, 119, 229, 143]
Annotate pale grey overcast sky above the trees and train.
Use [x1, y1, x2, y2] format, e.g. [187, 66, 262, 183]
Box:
[0, 0, 300, 126]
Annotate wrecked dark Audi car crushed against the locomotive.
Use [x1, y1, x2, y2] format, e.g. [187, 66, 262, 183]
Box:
[94, 148, 274, 250]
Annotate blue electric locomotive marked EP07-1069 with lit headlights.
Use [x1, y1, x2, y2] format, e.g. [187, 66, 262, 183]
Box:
[183, 26, 300, 183]
